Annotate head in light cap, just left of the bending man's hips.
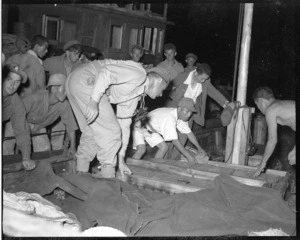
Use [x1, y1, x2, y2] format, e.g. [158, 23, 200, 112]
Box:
[47, 73, 67, 102]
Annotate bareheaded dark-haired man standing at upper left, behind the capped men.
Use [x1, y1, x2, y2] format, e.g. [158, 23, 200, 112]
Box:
[6, 35, 48, 98]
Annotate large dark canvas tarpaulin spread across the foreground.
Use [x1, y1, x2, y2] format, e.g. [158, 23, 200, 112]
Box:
[59, 172, 296, 236]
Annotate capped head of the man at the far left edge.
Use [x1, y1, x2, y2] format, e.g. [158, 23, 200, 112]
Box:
[2, 63, 27, 96]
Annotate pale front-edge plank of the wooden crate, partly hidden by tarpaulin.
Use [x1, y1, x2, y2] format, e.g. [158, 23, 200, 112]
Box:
[127, 158, 266, 187]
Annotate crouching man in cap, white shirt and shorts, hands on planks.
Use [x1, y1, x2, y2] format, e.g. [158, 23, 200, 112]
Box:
[133, 98, 204, 162]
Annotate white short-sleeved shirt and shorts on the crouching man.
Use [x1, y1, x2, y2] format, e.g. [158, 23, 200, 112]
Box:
[133, 108, 191, 149]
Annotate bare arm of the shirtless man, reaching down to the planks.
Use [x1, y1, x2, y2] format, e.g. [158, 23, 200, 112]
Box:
[254, 107, 277, 177]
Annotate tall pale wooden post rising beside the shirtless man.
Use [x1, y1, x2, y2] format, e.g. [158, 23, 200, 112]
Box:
[232, 3, 254, 165]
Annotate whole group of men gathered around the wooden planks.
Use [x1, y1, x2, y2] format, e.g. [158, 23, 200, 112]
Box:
[2, 35, 296, 178]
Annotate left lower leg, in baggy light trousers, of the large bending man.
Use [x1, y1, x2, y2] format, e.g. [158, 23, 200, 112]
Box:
[75, 126, 98, 172]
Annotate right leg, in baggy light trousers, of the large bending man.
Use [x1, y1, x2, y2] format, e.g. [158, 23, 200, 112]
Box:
[90, 95, 121, 178]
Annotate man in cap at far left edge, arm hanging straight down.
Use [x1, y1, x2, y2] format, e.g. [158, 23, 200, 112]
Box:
[2, 63, 35, 170]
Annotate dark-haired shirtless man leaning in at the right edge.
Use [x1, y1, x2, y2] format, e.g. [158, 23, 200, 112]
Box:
[253, 87, 296, 177]
